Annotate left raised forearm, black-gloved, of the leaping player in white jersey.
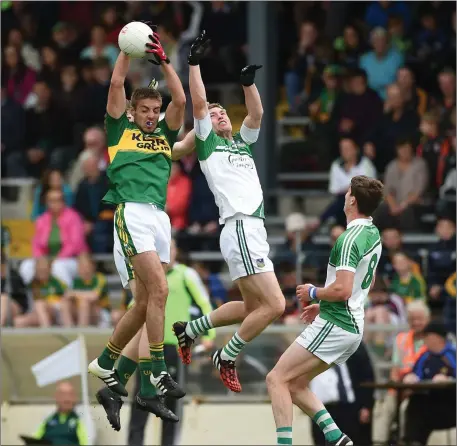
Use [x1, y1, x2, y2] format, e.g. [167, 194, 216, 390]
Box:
[188, 31, 210, 119]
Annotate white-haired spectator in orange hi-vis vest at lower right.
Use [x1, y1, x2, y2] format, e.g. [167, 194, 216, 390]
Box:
[373, 301, 430, 444]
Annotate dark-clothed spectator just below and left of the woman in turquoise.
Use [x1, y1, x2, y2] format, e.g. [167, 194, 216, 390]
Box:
[338, 69, 383, 145]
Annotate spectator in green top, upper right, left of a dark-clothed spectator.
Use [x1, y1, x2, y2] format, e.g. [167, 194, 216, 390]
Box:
[299, 65, 341, 124]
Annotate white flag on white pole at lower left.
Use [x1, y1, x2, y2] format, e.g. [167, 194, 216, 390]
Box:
[32, 335, 95, 445]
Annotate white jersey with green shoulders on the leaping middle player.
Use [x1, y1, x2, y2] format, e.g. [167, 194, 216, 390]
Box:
[194, 113, 265, 224]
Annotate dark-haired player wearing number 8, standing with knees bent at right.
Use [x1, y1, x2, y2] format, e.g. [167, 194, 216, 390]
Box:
[267, 176, 383, 446]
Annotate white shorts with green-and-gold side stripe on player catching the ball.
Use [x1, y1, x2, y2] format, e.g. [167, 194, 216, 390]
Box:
[113, 203, 171, 288]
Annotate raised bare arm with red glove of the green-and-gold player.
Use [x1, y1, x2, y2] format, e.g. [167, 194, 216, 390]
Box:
[146, 32, 186, 130]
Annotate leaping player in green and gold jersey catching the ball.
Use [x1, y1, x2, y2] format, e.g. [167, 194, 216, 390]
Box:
[89, 32, 186, 398]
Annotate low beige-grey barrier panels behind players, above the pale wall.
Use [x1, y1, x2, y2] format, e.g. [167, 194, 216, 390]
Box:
[1, 325, 405, 403]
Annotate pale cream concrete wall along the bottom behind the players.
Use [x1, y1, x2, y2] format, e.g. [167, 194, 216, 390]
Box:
[1, 403, 456, 446]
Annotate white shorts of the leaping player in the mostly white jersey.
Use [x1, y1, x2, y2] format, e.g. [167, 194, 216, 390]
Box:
[220, 214, 274, 280]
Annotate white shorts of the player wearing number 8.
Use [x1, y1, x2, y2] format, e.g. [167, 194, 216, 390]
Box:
[295, 316, 363, 364]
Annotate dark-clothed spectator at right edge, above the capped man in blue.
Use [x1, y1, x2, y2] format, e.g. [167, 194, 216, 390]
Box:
[428, 218, 456, 300]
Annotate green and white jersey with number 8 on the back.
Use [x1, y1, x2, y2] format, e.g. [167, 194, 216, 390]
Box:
[319, 218, 382, 333]
